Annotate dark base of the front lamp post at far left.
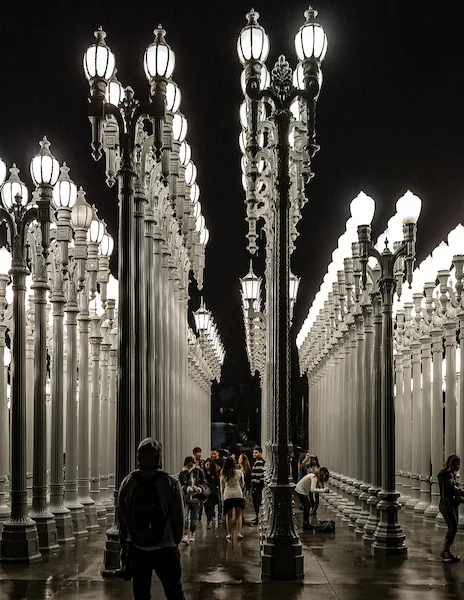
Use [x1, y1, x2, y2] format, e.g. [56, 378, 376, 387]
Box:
[0, 519, 42, 562]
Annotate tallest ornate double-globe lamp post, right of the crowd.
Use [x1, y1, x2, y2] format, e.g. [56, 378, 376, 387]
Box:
[237, 3, 327, 579]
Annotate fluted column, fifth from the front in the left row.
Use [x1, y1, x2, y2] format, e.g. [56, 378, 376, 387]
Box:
[77, 286, 99, 533]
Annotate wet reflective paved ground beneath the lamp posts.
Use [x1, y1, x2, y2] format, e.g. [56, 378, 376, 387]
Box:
[0, 506, 464, 600]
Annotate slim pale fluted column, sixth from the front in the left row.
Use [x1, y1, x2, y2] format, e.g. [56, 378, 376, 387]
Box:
[90, 314, 106, 529]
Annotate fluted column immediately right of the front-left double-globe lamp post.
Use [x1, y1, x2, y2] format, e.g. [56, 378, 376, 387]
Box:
[30, 255, 59, 552]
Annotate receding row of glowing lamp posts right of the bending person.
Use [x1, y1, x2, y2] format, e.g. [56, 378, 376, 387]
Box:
[297, 191, 421, 554]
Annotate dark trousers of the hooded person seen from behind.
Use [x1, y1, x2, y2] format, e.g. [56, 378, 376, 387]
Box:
[131, 546, 185, 600]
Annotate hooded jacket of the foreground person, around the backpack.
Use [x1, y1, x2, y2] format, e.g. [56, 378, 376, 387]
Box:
[117, 438, 184, 555]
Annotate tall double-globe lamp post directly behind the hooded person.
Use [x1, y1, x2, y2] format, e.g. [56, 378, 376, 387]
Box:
[84, 26, 175, 574]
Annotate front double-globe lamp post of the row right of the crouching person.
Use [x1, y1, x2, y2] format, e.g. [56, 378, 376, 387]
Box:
[358, 192, 421, 555]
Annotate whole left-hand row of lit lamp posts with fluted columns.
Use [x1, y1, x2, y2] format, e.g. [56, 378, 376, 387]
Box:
[0, 138, 121, 561]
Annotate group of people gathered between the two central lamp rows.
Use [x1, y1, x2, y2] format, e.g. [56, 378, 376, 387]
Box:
[179, 446, 264, 544]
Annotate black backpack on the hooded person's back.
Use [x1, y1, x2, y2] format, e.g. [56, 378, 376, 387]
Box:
[127, 471, 168, 548]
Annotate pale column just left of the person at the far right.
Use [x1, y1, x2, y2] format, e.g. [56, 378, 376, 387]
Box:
[424, 327, 443, 523]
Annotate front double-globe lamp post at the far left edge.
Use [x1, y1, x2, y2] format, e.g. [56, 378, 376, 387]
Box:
[0, 138, 59, 561]
